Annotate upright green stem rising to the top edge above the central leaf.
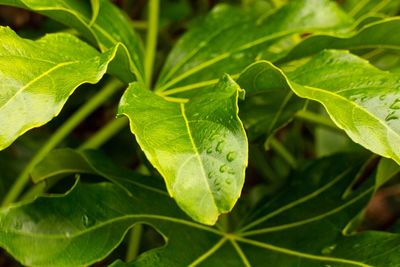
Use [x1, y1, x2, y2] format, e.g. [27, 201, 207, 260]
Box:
[144, 0, 160, 88]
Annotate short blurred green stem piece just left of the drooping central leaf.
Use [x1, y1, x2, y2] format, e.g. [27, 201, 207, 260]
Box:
[78, 117, 129, 150]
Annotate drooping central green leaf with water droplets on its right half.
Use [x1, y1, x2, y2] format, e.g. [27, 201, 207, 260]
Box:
[119, 76, 248, 224]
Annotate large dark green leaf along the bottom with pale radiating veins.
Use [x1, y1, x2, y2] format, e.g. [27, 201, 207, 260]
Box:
[0, 152, 400, 267]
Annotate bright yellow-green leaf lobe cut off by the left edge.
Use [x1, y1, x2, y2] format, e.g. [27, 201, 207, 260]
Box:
[0, 27, 119, 149]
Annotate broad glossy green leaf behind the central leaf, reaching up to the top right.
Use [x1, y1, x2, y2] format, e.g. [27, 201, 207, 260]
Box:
[157, 0, 352, 94]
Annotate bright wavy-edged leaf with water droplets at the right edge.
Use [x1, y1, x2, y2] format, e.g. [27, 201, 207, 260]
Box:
[244, 50, 400, 163]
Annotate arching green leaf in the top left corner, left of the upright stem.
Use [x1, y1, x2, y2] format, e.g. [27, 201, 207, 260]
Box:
[0, 0, 143, 82]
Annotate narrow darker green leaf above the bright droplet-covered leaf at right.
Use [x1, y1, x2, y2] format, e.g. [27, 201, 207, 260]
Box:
[276, 17, 400, 64]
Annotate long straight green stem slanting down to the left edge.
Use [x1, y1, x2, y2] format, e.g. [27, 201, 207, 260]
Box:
[2, 80, 123, 206]
